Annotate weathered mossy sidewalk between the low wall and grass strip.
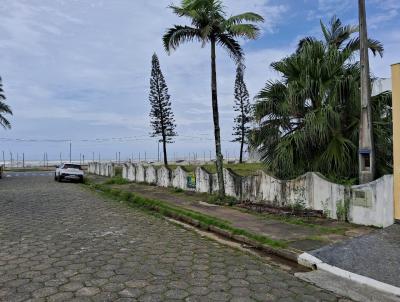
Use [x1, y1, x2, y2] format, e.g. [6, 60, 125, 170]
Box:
[97, 178, 373, 258]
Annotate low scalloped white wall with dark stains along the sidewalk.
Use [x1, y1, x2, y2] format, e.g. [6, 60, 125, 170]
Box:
[88, 163, 394, 227]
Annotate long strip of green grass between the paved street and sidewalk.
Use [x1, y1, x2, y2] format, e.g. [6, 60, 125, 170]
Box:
[86, 178, 287, 248]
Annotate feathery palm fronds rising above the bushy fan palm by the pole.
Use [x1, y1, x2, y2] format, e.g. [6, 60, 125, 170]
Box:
[298, 16, 384, 57]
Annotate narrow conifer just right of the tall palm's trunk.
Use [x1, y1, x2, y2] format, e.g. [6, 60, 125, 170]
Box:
[233, 65, 251, 163]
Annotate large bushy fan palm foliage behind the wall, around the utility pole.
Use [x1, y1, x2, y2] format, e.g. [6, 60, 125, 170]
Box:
[251, 16, 392, 179]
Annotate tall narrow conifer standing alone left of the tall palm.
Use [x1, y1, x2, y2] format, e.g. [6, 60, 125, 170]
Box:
[149, 53, 177, 165]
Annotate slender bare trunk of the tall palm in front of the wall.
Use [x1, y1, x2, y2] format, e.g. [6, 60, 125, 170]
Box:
[211, 38, 225, 198]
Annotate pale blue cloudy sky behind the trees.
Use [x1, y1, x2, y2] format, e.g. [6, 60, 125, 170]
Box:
[0, 0, 400, 161]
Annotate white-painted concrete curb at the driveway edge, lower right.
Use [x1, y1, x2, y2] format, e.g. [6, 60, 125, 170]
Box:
[297, 253, 400, 296]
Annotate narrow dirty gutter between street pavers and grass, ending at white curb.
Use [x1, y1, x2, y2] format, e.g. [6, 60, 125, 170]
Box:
[165, 218, 311, 275]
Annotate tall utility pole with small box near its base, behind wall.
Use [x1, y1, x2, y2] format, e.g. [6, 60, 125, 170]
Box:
[358, 0, 375, 184]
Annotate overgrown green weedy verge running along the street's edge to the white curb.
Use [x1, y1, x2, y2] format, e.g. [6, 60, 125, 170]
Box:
[86, 183, 290, 251]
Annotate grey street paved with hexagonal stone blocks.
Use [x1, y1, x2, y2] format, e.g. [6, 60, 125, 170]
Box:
[0, 177, 345, 302]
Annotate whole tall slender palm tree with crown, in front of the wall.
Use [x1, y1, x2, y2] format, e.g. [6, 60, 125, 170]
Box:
[163, 0, 264, 198]
